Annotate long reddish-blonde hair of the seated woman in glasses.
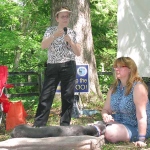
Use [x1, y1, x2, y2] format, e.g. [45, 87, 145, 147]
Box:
[111, 57, 148, 95]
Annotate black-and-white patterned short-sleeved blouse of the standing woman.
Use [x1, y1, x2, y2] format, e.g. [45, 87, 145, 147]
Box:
[44, 26, 77, 64]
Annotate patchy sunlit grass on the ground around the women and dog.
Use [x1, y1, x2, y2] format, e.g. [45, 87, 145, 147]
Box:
[0, 97, 150, 150]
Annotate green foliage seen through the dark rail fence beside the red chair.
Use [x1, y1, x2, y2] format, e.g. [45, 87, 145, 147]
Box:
[7, 72, 42, 97]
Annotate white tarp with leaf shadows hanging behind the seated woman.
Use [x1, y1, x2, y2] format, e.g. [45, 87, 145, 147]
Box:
[117, 0, 150, 77]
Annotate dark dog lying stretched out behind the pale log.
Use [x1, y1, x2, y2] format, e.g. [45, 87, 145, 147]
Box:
[11, 121, 106, 138]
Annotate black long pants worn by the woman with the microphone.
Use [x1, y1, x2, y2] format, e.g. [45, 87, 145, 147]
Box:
[34, 61, 76, 126]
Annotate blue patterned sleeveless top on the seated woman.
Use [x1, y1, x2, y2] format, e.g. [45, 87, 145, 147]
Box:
[110, 82, 150, 127]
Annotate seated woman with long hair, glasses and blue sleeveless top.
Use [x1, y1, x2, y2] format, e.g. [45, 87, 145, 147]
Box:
[102, 57, 150, 146]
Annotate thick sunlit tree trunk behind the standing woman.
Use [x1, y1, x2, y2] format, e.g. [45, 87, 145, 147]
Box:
[51, 0, 102, 100]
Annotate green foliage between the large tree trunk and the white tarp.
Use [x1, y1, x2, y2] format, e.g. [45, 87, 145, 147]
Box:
[90, 0, 117, 92]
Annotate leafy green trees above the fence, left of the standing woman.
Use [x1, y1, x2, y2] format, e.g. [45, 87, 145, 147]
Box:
[0, 0, 50, 71]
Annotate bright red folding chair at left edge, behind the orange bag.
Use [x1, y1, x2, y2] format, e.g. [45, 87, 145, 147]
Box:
[0, 66, 13, 124]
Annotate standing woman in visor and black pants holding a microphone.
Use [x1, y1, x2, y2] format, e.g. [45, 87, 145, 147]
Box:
[33, 7, 81, 127]
